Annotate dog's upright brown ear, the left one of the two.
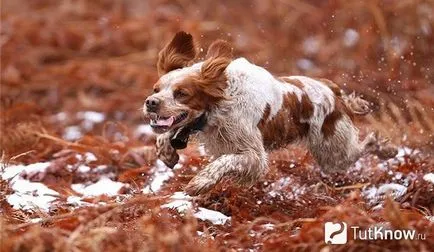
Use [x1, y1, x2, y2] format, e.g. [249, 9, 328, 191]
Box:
[157, 31, 196, 76]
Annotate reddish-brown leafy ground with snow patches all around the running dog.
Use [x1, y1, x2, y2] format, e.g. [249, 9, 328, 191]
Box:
[0, 0, 434, 251]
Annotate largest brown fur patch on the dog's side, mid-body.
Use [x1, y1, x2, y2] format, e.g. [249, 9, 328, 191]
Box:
[258, 93, 313, 149]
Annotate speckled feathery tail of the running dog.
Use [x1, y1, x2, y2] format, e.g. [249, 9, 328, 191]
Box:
[321, 79, 373, 116]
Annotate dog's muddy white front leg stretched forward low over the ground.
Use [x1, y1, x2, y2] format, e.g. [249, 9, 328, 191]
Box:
[184, 151, 267, 196]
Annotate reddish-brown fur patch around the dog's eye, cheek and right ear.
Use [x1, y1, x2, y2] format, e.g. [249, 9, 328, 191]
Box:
[173, 57, 231, 110]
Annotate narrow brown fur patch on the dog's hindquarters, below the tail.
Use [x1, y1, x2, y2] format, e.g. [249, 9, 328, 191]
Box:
[321, 97, 354, 139]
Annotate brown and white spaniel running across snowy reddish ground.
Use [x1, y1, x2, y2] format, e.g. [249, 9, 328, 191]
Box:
[144, 32, 396, 195]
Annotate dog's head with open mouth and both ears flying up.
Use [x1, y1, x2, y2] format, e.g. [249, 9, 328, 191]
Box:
[143, 32, 232, 133]
